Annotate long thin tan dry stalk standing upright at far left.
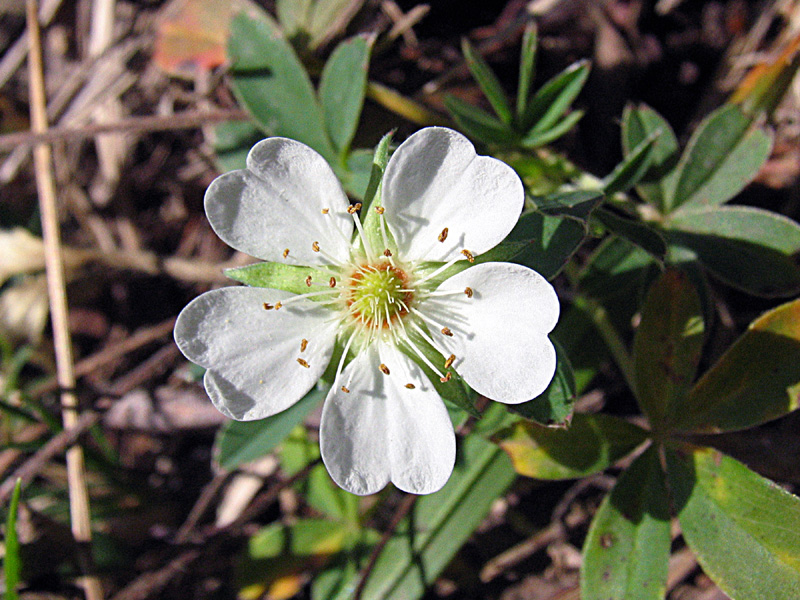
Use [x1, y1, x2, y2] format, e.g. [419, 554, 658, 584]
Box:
[27, 0, 103, 600]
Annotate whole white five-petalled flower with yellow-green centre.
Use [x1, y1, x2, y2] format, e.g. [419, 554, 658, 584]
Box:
[175, 127, 559, 495]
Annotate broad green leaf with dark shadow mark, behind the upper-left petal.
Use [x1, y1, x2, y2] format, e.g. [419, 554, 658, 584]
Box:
[228, 14, 336, 163]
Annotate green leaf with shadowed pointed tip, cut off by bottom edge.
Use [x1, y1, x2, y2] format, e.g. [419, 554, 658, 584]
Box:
[581, 446, 670, 600]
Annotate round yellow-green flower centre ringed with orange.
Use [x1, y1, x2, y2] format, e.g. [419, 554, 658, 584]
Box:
[346, 263, 414, 328]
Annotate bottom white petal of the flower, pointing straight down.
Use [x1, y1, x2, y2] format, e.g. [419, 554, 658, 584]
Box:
[320, 345, 455, 495]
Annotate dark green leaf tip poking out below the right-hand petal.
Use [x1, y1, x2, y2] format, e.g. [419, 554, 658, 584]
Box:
[508, 341, 577, 426]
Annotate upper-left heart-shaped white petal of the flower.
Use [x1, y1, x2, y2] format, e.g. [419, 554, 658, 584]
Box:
[205, 137, 353, 266]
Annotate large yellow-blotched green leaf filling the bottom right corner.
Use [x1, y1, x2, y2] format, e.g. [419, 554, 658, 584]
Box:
[667, 449, 800, 600]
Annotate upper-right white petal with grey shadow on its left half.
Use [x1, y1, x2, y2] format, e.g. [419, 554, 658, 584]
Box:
[382, 127, 525, 261]
